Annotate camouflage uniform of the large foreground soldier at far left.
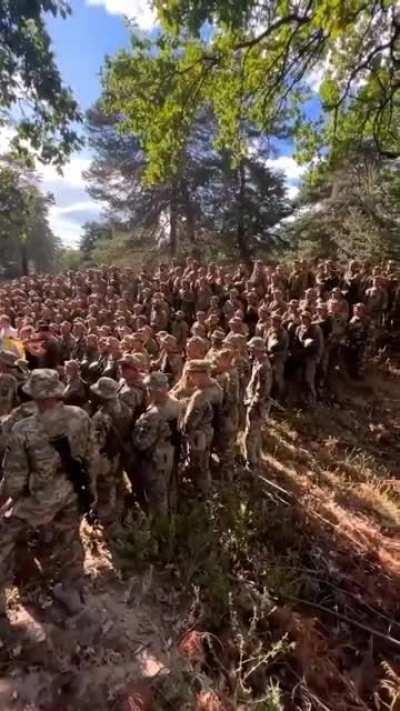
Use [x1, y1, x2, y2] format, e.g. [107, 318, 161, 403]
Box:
[0, 403, 95, 611]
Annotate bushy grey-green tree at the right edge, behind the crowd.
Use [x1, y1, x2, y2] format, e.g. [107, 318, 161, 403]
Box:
[280, 144, 400, 261]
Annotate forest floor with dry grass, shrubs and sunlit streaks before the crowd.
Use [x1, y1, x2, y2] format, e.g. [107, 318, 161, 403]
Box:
[0, 361, 400, 711]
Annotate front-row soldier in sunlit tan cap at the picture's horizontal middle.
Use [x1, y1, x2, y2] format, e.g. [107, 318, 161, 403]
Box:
[182, 360, 223, 495]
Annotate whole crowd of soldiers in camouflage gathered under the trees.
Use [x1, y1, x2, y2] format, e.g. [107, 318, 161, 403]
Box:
[0, 258, 400, 631]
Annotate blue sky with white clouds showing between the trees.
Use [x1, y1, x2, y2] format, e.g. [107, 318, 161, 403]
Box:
[20, 0, 318, 246]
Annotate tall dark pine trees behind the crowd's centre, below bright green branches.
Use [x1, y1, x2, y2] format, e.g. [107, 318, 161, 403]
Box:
[85, 106, 290, 259]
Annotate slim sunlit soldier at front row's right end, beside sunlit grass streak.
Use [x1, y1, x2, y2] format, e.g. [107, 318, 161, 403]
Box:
[243, 336, 272, 469]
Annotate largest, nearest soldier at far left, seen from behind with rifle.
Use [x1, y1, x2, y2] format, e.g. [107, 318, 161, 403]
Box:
[0, 369, 95, 630]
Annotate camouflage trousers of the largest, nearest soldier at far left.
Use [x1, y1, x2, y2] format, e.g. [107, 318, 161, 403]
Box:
[0, 503, 84, 612]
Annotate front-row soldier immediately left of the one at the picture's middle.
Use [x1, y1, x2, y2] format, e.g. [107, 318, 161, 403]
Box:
[132, 372, 179, 516]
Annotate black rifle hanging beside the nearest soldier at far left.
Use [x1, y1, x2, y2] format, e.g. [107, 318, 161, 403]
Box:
[50, 435, 96, 523]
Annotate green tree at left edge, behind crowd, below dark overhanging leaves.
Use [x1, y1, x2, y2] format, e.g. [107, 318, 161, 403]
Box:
[0, 158, 58, 277]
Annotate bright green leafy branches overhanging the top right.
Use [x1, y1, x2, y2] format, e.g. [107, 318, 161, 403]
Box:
[104, 0, 400, 181]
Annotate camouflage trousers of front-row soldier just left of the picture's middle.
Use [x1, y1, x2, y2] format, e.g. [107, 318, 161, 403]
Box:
[139, 443, 175, 516]
